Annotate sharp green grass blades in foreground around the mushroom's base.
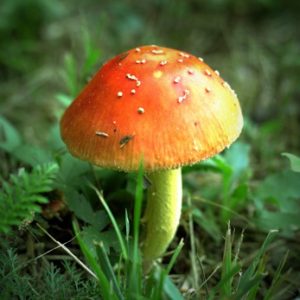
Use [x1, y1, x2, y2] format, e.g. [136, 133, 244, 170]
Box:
[0, 168, 287, 300]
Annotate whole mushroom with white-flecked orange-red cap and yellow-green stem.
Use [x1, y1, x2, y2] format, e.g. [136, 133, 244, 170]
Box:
[61, 45, 243, 263]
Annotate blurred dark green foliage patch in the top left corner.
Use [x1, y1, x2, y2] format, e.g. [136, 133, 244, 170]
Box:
[0, 0, 62, 79]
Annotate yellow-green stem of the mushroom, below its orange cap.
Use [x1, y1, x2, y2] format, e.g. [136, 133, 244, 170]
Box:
[143, 168, 182, 265]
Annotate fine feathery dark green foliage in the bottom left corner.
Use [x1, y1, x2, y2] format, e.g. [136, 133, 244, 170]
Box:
[0, 249, 99, 300]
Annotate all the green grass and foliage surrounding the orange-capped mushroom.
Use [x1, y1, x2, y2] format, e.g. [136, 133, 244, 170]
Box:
[0, 0, 300, 300]
